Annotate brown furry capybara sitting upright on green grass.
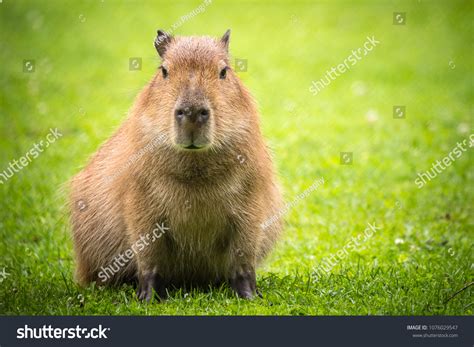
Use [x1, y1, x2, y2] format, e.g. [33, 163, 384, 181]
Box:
[70, 30, 282, 301]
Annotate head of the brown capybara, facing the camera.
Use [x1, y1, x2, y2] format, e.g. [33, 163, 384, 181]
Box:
[137, 30, 257, 152]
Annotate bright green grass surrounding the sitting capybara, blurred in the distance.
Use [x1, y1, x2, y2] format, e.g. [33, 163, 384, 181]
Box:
[0, 0, 474, 315]
